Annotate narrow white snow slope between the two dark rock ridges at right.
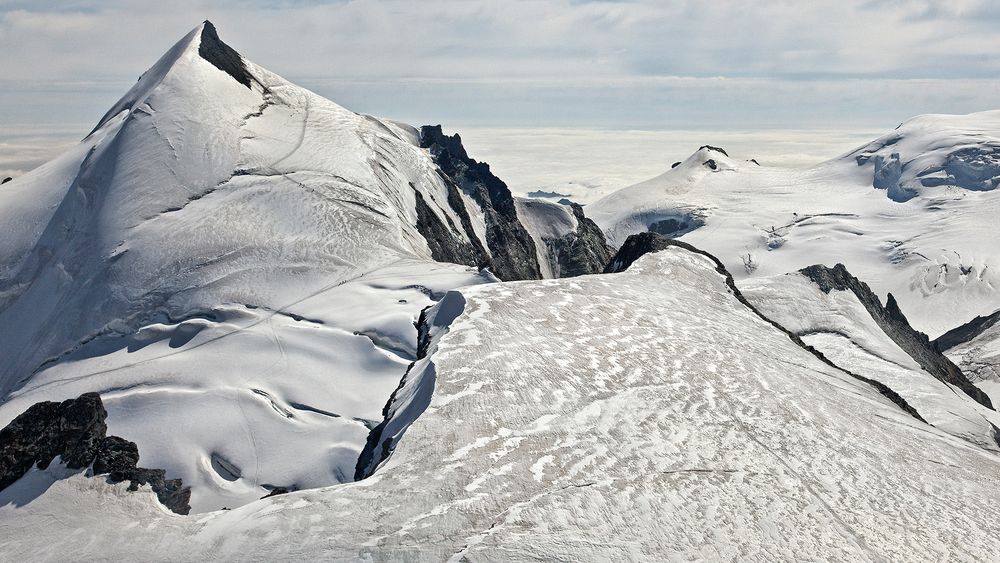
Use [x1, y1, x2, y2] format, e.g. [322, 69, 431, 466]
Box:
[740, 273, 1000, 451]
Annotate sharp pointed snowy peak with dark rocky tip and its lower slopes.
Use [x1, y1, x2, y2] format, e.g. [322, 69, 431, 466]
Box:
[0, 23, 493, 511]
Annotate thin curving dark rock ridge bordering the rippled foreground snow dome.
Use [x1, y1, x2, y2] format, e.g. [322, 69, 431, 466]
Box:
[604, 232, 927, 423]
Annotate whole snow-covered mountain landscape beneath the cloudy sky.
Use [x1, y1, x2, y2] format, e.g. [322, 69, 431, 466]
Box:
[0, 18, 1000, 561]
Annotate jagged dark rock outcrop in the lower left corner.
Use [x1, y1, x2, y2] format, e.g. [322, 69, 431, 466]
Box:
[0, 393, 191, 514]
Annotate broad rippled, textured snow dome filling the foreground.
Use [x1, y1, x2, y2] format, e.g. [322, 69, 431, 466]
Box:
[0, 248, 1000, 561]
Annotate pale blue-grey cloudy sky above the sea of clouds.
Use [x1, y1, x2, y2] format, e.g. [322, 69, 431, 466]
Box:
[0, 0, 1000, 177]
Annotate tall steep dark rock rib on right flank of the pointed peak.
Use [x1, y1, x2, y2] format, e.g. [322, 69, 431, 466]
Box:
[420, 125, 541, 281]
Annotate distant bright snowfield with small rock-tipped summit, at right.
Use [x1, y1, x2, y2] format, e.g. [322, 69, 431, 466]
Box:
[586, 112, 1000, 337]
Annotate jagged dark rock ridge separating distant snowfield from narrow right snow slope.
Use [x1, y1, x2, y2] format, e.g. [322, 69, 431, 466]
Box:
[799, 264, 993, 409]
